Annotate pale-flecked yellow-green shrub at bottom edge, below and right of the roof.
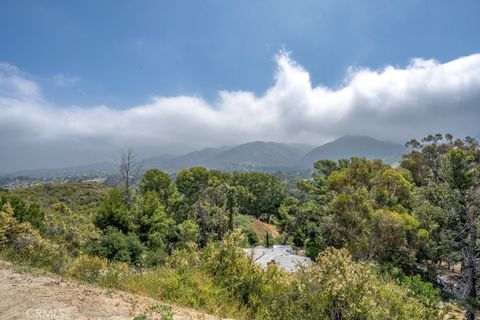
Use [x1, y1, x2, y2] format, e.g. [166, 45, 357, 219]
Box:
[279, 248, 438, 319]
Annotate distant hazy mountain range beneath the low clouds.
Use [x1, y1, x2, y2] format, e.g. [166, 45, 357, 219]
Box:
[1, 136, 406, 177]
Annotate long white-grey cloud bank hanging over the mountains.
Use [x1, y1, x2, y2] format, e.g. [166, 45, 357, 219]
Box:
[0, 53, 480, 172]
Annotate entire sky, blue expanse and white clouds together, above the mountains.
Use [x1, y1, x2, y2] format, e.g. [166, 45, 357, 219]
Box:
[0, 0, 480, 172]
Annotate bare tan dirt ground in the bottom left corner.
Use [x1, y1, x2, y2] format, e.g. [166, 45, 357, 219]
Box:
[0, 261, 218, 320]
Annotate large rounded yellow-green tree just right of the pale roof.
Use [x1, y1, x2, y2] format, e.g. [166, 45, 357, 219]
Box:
[303, 158, 419, 270]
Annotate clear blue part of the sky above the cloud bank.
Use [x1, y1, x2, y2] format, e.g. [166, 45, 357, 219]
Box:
[0, 0, 480, 108]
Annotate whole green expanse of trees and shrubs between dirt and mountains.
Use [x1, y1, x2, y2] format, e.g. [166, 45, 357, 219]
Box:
[0, 134, 480, 319]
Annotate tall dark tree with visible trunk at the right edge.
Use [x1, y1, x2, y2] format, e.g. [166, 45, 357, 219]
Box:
[401, 134, 480, 319]
